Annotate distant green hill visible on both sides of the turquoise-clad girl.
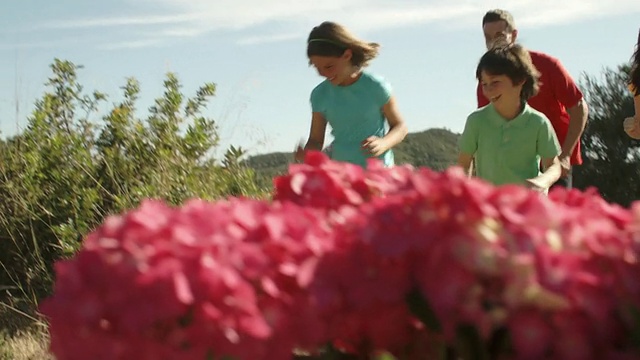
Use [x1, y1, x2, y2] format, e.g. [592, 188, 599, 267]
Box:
[245, 129, 460, 187]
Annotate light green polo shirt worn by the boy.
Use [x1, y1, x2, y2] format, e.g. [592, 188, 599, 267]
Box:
[459, 104, 561, 185]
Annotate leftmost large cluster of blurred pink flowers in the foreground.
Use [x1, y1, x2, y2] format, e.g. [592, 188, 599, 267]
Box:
[42, 199, 333, 360]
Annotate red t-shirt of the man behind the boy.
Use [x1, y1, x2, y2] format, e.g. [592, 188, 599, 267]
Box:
[477, 51, 582, 165]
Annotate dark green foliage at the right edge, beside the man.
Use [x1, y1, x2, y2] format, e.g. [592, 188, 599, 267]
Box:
[574, 65, 640, 206]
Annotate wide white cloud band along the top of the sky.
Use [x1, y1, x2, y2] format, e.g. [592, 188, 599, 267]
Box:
[30, 0, 640, 48]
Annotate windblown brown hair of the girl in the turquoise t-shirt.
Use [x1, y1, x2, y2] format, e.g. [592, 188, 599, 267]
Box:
[307, 21, 380, 67]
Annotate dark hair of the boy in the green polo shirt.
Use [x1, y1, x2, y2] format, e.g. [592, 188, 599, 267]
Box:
[476, 43, 540, 101]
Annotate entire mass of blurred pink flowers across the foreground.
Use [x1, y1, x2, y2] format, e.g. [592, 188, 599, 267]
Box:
[42, 153, 640, 360]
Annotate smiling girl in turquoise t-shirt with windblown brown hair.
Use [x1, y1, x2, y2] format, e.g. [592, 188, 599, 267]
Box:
[295, 22, 407, 167]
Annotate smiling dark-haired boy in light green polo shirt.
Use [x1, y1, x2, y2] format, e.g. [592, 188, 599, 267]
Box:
[458, 43, 562, 193]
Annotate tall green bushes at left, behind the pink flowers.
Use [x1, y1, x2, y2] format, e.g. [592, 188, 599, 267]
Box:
[0, 59, 264, 302]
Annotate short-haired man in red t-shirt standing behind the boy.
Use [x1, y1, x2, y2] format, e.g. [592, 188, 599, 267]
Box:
[477, 9, 588, 188]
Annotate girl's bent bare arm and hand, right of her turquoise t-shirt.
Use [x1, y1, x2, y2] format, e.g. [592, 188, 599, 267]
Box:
[362, 96, 408, 156]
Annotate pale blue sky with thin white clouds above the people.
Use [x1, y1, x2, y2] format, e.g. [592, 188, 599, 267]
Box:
[0, 0, 640, 153]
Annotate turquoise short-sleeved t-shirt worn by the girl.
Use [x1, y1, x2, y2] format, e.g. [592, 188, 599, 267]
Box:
[311, 71, 394, 167]
